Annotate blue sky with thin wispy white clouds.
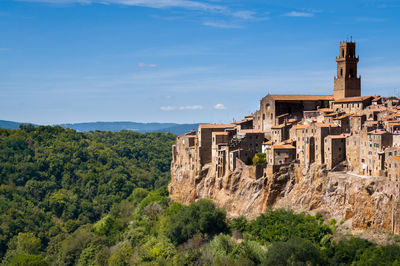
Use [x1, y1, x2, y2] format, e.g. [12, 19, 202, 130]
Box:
[0, 0, 400, 124]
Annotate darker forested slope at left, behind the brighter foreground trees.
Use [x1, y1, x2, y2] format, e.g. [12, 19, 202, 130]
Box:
[0, 125, 175, 257]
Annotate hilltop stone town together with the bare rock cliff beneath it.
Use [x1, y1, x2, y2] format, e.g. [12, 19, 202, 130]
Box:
[169, 41, 400, 232]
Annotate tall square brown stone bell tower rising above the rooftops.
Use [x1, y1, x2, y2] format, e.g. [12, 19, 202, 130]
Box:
[333, 41, 361, 100]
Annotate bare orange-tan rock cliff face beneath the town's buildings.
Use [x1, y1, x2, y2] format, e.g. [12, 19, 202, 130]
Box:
[169, 161, 400, 234]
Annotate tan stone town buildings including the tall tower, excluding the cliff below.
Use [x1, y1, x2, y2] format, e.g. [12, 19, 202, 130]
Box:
[172, 42, 400, 182]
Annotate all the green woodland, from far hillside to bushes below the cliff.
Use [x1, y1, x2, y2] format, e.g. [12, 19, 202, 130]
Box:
[0, 125, 400, 265]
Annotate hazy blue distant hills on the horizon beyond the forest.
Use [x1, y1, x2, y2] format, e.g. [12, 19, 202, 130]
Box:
[0, 120, 199, 135]
